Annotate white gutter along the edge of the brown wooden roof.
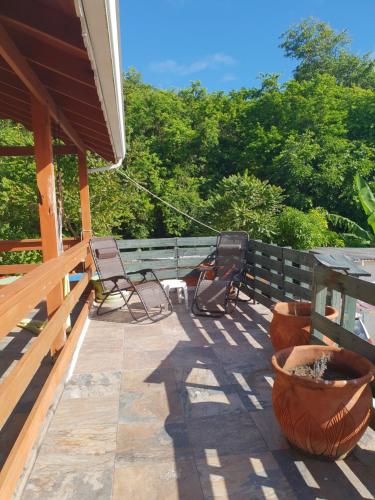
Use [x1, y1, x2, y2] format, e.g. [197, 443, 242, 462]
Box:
[75, 0, 125, 162]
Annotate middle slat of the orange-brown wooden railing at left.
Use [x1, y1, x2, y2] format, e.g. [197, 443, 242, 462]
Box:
[0, 274, 90, 427]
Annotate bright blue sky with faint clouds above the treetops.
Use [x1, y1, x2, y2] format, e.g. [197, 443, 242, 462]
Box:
[120, 0, 375, 91]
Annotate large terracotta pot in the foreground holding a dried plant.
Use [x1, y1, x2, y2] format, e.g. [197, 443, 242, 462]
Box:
[272, 346, 375, 460]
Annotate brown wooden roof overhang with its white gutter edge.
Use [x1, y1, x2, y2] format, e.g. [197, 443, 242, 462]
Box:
[0, 0, 125, 162]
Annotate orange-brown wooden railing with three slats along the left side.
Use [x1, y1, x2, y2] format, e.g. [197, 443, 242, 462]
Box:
[0, 241, 93, 498]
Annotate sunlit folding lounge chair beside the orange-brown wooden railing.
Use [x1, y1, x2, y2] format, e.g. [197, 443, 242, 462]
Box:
[90, 238, 172, 321]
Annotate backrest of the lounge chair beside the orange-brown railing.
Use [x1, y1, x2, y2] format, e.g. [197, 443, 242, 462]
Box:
[89, 237, 127, 288]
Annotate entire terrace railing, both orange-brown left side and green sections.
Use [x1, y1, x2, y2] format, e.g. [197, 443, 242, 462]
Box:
[0, 237, 375, 498]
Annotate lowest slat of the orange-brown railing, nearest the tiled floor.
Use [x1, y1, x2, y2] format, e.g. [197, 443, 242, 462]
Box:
[0, 293, 94, 499]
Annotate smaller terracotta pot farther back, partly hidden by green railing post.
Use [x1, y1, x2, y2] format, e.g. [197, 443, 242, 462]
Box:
[270, 302, 338, 351]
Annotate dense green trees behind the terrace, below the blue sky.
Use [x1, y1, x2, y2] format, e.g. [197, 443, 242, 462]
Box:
[0, 19, 375, 262]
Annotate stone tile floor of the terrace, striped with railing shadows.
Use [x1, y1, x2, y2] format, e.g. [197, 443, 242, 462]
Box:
[22, 294, 375, 500]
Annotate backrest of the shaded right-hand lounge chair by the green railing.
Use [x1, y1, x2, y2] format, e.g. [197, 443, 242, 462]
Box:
[215, 231, 249, 278]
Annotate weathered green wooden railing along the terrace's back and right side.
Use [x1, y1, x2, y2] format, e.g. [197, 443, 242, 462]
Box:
[118, 237, 375, 359]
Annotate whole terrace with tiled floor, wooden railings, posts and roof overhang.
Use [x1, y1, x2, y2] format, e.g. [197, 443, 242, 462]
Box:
[0, 0, 375, 500]
